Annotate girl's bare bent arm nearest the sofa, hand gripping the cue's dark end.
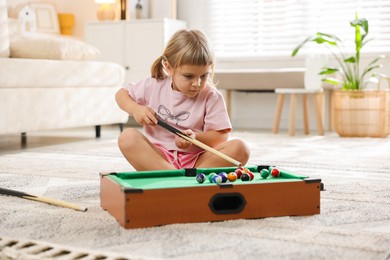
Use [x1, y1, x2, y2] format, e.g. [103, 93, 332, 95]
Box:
[115, 88, 157, 125]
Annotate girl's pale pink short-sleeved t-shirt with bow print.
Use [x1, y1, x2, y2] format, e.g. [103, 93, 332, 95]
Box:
[124, 77, 232, 153]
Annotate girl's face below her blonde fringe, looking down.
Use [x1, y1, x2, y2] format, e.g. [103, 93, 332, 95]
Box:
[168, 65, 211, 98]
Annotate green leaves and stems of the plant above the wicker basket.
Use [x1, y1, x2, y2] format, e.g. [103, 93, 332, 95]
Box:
[291, 14, 383, 90]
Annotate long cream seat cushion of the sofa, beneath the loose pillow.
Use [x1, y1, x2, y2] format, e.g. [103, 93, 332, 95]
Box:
[0, 58, 125, 88]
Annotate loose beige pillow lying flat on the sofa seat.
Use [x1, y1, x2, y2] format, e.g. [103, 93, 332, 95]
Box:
[10, 34, 100, 60]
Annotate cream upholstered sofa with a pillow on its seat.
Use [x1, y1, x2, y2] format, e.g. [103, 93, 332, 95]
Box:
[0, 0, 128, 137]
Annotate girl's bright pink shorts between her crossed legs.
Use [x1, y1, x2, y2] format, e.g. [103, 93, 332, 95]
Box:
[155, 144, 204, 169]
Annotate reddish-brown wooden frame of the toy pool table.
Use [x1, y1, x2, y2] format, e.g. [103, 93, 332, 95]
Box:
[100, 167, 323, 228]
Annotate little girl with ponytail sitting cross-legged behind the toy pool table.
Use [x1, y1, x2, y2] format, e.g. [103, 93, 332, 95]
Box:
[116, 30, 249, 171]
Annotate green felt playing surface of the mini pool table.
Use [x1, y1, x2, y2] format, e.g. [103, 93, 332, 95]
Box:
[109, 166, 307, 190]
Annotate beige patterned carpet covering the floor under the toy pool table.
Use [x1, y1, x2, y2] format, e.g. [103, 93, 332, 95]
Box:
[0, 132, 390, 260]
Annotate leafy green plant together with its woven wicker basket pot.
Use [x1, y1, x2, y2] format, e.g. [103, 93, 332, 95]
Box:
[292, 15, 390, 137]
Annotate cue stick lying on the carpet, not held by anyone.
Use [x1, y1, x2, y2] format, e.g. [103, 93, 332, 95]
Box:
[0, 188, 87, 211]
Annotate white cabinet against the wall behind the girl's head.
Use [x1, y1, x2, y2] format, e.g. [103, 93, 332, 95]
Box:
[85, 19, 186, 82]
